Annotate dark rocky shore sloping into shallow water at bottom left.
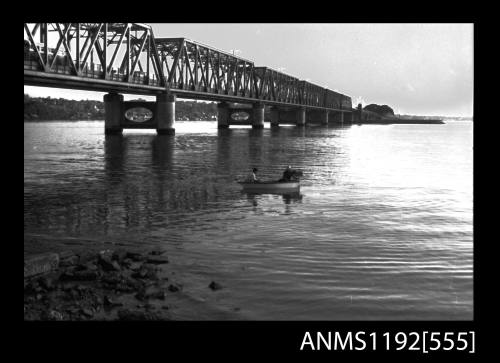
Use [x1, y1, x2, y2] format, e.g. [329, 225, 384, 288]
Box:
[24, 249, 242, 321]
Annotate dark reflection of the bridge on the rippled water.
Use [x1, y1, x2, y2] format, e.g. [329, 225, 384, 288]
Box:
[25, 128, 335, 235]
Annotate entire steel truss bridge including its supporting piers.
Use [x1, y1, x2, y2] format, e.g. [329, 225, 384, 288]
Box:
[24, 23, 362, 134]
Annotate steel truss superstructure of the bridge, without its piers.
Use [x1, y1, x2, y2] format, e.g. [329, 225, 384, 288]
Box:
[24, 23, 360, 134]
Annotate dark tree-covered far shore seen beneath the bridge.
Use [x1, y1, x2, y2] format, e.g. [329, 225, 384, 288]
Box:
[24, 94, 217, 121]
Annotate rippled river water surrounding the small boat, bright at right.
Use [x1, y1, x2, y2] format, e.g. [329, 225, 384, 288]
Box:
[24, 121, 473, 320]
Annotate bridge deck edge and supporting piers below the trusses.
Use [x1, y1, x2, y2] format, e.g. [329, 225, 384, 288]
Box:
[24, 70, 354, 134]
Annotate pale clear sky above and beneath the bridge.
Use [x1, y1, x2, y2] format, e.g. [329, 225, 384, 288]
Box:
[24, 23, 474, 117]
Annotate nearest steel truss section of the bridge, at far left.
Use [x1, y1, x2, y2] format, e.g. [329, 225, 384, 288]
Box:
[24, 23, 164, 85]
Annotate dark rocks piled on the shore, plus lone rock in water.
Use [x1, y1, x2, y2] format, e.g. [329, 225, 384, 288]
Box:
[24, 249, 222, 321]
